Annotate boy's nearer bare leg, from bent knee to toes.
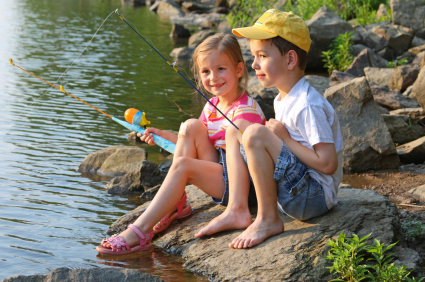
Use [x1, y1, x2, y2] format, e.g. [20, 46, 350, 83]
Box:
[229, 125, 284, 249]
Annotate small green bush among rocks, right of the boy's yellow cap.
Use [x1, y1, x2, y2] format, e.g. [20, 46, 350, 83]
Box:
[321, 32, 354, 75]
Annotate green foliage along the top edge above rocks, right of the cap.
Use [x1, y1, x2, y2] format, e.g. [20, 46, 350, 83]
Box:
[284, 0, 391, 25]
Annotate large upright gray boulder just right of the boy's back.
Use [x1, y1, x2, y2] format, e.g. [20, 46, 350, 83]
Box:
[325, 77, 399, 172]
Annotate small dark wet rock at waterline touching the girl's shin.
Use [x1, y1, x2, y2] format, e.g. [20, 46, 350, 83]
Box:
[106, 161, 165, 194]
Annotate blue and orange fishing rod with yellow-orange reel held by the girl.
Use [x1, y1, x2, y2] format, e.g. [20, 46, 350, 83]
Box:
[9, 59, 176, 154]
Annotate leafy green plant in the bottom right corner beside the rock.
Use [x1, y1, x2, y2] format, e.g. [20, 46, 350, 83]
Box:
[326, 232, 425, 282]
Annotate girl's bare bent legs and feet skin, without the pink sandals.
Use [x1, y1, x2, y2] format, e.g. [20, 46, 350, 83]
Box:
[103, 120, 225, 248]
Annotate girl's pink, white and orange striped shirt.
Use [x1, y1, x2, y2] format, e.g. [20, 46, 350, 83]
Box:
[200, 93, 266, 150]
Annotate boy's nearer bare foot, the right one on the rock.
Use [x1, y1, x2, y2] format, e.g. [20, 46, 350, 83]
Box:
[229, 218, 285, 249]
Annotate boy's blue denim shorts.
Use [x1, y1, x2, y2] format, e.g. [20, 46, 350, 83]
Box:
[240, 142, 328, 220]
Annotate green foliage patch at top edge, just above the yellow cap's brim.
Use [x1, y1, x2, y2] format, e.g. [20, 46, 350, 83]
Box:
[227, 0, 275, 28]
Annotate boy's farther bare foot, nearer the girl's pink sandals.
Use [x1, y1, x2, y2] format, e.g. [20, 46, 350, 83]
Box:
[195, 209, 252, 238]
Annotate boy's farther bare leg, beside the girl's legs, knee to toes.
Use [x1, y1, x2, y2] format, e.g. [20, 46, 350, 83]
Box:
[195, 119, 252, 238]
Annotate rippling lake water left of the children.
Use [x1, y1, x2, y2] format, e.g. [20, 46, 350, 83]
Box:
[0, 0, 203, 281]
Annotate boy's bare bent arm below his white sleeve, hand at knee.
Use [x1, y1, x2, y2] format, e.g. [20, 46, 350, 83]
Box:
[266, 119, 338, 175]
